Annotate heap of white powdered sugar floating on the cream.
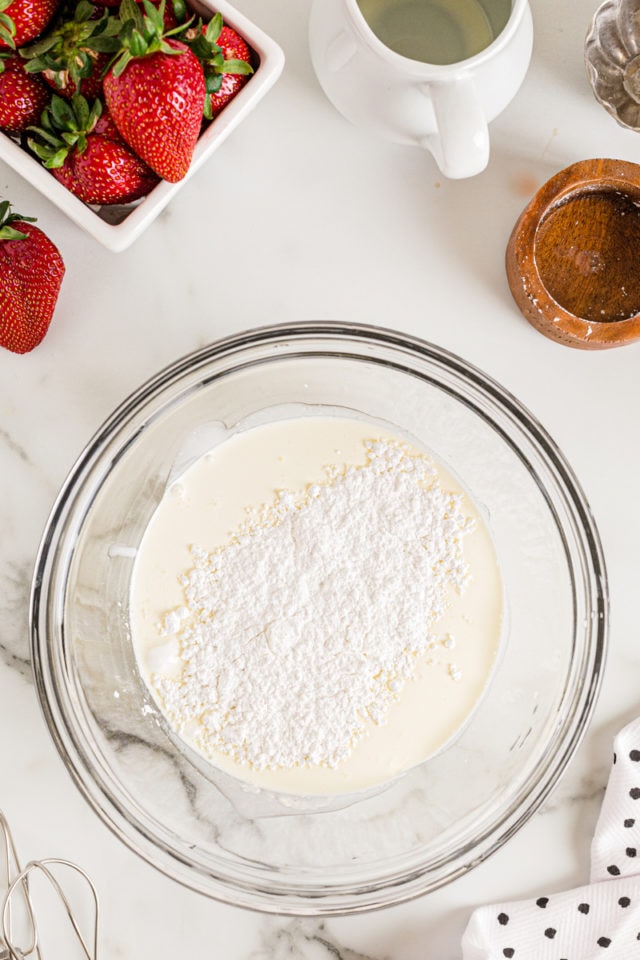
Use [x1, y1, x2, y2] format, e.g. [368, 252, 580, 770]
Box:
[152, 441, 472, 769]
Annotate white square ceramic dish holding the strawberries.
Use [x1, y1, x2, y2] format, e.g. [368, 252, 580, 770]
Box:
[0, 0, 284, 253]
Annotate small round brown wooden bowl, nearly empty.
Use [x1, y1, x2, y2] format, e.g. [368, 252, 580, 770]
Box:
[506, 160, 640, 350]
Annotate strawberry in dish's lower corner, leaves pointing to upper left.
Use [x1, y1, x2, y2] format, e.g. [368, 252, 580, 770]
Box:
[28, 94, 158, 204]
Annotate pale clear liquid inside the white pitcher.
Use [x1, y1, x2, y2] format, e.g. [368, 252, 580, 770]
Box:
[358, 0, 511, 65]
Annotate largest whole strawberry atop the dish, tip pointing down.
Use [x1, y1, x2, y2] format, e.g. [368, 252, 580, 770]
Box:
[103, 0, 205, 183]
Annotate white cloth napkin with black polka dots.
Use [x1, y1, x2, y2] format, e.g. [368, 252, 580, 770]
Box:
[462, 719, 640, 960]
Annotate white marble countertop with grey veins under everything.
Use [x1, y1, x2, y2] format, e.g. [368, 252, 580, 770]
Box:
[0, 0, 640, 960]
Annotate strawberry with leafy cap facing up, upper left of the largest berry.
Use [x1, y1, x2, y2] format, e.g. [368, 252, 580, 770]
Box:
[20, 0, 121, 99]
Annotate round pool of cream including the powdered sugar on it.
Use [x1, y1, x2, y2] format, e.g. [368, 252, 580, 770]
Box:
[131, 416, 503, 795]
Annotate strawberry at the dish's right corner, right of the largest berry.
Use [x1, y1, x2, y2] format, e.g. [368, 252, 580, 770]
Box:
[194, 13, 253, 120]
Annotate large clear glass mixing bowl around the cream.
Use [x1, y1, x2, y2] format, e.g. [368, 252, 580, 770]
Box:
[31, 323, 608, 916]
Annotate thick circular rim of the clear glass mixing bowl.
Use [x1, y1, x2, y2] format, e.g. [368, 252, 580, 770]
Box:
[30, 322, 608, 916]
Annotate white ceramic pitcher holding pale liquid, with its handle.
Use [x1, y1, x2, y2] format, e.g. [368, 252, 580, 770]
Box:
[309, 0, 533, 178]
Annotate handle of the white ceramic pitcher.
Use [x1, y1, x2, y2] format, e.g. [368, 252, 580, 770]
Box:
[420, 77, 489, 180]
